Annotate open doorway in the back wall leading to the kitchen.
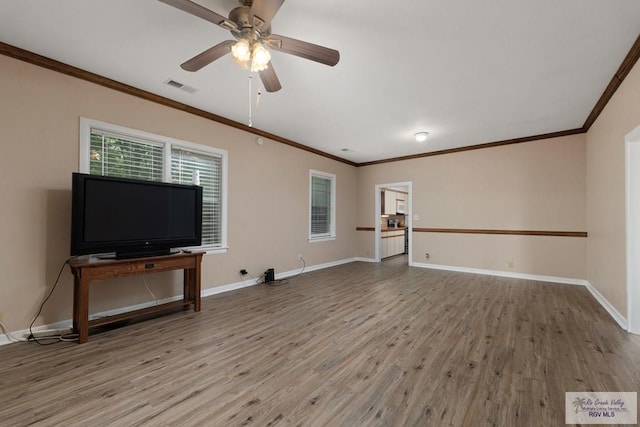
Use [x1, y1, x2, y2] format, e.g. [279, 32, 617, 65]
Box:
[374, 182, 413, 265]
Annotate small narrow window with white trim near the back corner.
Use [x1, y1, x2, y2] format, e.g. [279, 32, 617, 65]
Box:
[309, 170, 336, 240]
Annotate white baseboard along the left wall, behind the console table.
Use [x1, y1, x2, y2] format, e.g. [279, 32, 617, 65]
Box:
[0, 258, 357, 345]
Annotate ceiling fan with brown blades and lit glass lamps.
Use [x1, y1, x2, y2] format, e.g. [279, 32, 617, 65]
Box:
[159, 0, 340, 92]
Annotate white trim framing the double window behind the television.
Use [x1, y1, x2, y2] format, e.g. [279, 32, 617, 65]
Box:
[78, 117, 229, 254]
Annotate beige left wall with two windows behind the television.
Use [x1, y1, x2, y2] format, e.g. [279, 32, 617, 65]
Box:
[0, 56, 357, 331]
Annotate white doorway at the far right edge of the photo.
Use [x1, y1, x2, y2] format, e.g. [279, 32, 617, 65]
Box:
[625, 126, 640, 334]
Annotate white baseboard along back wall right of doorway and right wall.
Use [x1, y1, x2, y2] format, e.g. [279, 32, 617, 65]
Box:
[411, 262, 628, 331]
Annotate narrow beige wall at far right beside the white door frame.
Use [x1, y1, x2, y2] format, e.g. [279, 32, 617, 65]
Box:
[587, 58, 640, 317]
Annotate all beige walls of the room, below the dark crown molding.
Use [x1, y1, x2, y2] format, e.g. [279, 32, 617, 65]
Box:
[0, 48, 640, 338]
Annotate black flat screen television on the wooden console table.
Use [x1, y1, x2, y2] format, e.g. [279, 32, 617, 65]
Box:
[71, 173, 202, 258]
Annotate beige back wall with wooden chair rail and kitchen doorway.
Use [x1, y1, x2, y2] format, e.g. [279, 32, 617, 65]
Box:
[358, 135, 586, 279]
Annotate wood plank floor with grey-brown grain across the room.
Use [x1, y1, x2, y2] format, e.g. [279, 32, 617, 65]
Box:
[0, 260, 640, 426]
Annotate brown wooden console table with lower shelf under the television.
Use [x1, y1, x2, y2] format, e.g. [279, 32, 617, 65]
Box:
[69, 252, 203, 343]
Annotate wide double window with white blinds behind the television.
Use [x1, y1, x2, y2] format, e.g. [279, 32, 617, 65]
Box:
[80, 118, 227, 252]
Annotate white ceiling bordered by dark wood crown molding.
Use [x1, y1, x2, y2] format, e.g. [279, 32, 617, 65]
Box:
[0, 0, 640, 163]
